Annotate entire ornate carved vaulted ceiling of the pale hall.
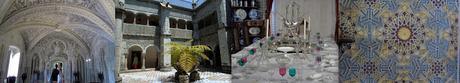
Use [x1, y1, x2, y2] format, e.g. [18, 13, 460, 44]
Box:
[0, 0, 115, 53]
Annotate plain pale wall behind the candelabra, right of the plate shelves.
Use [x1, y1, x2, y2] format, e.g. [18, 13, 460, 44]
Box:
[272, 0, 336, 37]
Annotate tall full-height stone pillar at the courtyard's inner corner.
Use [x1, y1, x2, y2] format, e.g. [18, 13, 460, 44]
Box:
[160, 6, 171, 71]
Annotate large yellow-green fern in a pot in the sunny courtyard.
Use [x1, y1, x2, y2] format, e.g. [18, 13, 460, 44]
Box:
[169, 41, 211, 83]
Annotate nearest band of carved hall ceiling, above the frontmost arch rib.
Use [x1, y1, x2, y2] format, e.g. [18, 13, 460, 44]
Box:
[0, 0, 115, 24]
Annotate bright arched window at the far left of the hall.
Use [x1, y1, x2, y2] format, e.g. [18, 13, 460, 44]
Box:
[7, 46, 21, 77]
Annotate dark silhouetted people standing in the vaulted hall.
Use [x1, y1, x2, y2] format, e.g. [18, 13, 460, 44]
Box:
[51, 63, 64, 83]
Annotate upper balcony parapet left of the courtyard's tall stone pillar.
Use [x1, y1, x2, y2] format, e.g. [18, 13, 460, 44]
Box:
[123, 23, 156, 36]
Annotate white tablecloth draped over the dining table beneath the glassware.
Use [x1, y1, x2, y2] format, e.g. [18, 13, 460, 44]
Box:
[232, 38, 339, 83]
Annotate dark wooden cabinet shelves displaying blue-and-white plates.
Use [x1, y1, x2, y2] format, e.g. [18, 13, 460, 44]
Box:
[229, 0, 266, 53]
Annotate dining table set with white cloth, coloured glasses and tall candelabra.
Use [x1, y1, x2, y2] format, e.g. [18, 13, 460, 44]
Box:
[232, 1, 338, 83]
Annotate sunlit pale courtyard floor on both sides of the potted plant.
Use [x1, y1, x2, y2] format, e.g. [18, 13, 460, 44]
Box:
[120, 70, 231, 83]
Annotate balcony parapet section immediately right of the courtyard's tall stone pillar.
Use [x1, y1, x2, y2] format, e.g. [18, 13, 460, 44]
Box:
[170, 28, 193, 39]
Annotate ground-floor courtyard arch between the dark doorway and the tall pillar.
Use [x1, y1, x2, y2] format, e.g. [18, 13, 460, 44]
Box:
[145, 45, 160, 68]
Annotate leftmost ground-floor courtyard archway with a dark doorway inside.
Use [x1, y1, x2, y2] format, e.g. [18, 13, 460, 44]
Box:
[128, 46, 142, 69]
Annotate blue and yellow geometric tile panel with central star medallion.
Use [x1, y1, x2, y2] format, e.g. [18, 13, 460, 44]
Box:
[338, 0, 460, 83]
